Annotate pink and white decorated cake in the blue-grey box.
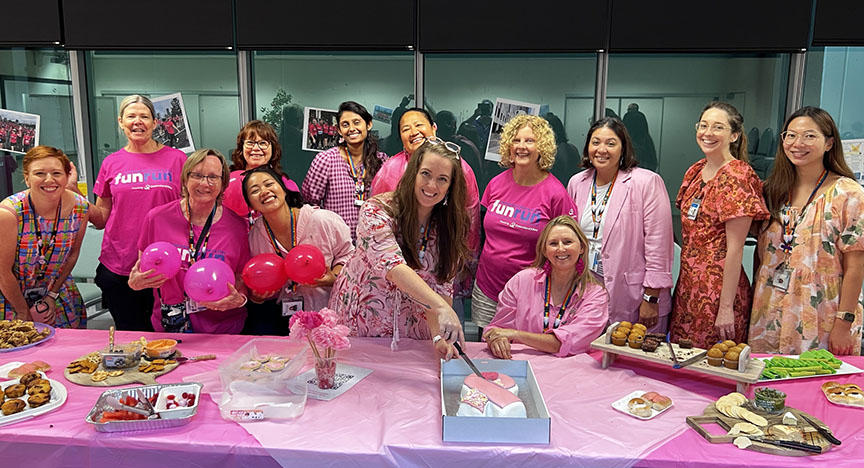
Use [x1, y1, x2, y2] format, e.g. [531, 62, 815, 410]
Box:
[456, 372, 527, 418]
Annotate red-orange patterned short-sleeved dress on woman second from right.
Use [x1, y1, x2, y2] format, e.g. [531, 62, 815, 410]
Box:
[669, 159, 769, 348]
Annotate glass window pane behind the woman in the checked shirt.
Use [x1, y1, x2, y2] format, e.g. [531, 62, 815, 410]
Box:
[251, 52, 414, 184]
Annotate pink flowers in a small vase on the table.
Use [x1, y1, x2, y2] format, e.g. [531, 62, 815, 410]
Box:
[288, 307, 351, 389]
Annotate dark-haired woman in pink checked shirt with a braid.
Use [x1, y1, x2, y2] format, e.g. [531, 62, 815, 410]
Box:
[302, 101, 387, 239]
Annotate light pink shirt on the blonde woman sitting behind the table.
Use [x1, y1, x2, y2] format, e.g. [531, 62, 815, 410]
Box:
[486, 268, 609, 357]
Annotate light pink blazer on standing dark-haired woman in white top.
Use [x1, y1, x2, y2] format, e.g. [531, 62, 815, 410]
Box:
[567, 168, 674, 332]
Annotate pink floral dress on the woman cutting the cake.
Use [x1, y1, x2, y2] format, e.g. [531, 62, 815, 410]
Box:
[330, 193, 453, 346]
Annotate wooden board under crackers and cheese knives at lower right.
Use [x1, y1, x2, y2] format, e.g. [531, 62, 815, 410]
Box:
[687, 401, 832, 457]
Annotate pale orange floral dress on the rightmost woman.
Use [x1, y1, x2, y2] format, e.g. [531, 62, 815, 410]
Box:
[749, 177, 864, 355]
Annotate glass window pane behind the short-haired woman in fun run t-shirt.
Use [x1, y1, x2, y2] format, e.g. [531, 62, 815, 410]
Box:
[88, 51, 240, 176]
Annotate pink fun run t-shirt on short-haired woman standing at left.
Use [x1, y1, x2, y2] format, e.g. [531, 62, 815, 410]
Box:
[93, 146, 186, 276]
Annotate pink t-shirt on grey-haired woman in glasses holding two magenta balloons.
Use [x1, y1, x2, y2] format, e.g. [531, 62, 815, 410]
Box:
[137, 201, 249, 334]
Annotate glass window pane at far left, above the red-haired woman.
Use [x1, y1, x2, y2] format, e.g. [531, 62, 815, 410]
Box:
[0, 49, 78, 198]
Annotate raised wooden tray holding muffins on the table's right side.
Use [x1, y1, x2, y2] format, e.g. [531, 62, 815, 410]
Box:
[591, 324, 765, 395]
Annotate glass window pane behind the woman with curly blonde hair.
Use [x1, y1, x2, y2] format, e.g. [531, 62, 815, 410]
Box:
[422, 54, 597, 195]
